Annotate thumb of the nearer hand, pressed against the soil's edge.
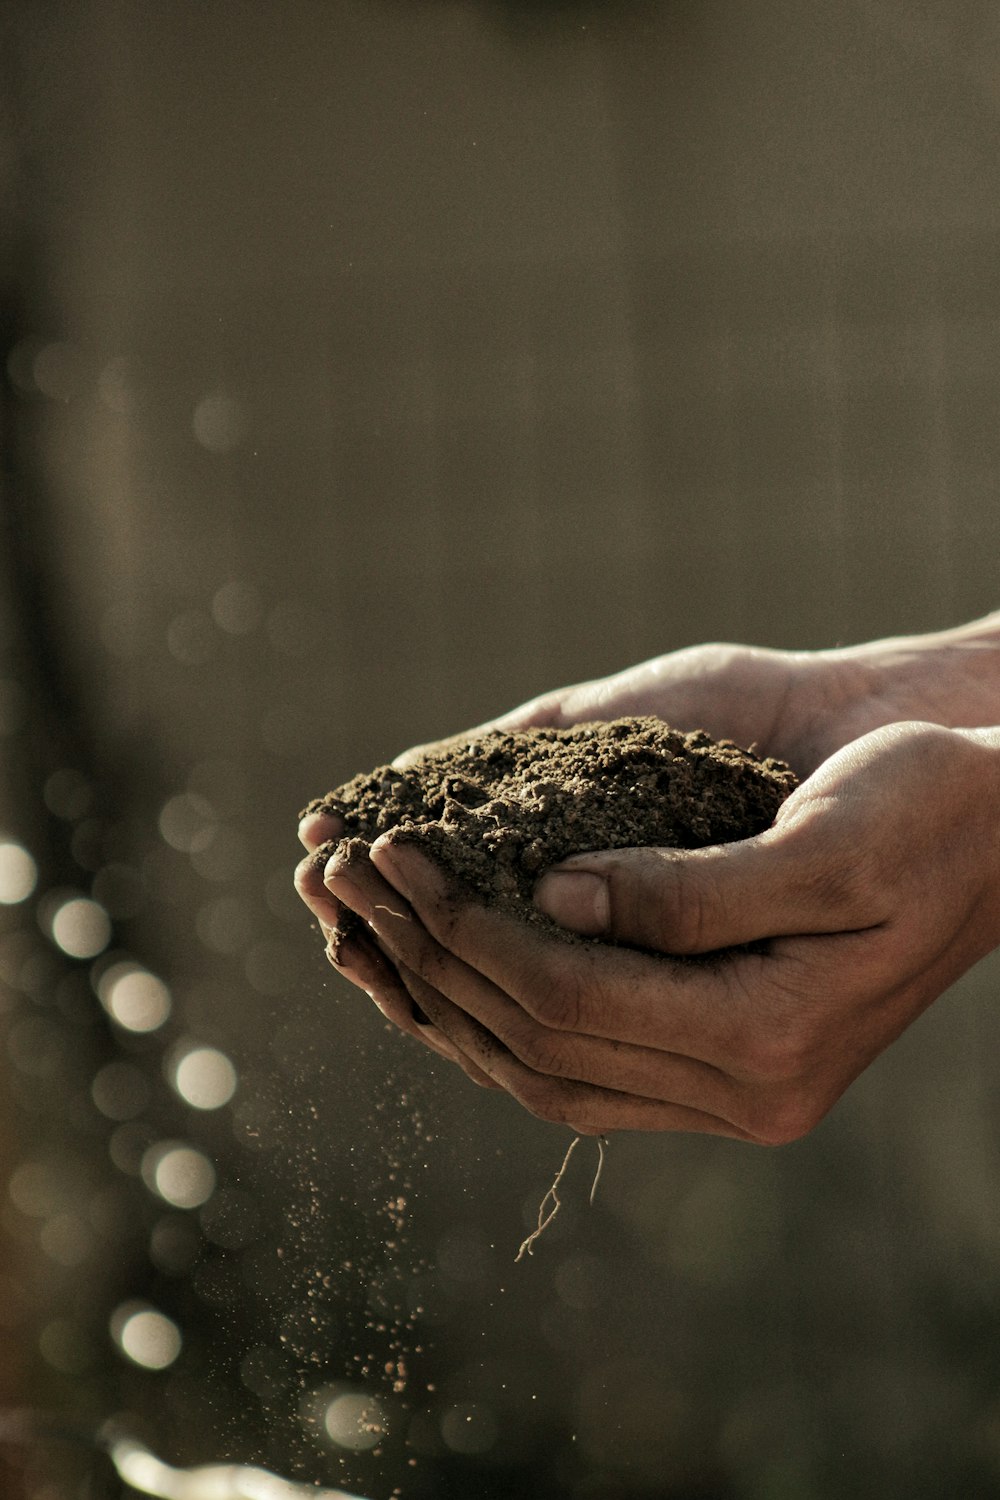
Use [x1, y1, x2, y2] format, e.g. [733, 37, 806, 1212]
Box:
[535, 828, 871, 954]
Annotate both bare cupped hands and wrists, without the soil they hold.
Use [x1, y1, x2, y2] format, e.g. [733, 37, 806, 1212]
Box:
[297, 617, 1000, 1145]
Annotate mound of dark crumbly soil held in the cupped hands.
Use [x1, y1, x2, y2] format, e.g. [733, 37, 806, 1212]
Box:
[303, 719, 798, 929]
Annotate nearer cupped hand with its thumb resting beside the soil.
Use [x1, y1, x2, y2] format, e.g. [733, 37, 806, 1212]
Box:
[320, 723, 1000, 1145]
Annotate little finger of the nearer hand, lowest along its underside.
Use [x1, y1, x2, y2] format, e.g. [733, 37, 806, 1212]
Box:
[406, 974, 753, 1140]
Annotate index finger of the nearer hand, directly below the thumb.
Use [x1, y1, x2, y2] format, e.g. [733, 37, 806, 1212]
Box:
[366, 839, 771, 1074]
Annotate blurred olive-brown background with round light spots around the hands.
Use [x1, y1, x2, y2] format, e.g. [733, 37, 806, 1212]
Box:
[0, 0, 1000, 1500]
